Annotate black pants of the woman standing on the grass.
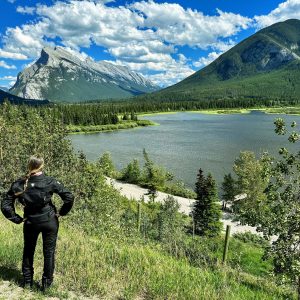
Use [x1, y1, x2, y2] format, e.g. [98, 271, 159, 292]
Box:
[22, 216, 59, 284]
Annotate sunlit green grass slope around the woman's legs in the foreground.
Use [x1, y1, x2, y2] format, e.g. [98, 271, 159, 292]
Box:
[0, 217, 296, 300]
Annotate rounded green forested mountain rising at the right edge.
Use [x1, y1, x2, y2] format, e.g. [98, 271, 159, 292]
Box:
[149, 19, 300, 100]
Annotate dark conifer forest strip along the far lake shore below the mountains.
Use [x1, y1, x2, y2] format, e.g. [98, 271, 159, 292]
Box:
[45, 97, 299, 125]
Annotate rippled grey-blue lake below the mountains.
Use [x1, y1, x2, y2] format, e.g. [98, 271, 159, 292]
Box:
[69, 111, 300, 188]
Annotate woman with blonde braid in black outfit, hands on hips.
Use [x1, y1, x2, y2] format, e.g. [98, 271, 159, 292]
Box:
[1, 156, 74, 290]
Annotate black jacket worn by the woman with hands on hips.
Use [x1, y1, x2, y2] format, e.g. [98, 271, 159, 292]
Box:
[1, 174, 74, 224]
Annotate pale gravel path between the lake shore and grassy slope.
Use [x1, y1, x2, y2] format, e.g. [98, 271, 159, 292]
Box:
[107, 178, 259, 234]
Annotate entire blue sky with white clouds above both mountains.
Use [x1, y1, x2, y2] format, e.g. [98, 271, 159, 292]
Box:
[0, 0, 300, 87]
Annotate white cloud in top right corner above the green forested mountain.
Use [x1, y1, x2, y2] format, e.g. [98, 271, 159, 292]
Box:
[254, 0, 300, 28]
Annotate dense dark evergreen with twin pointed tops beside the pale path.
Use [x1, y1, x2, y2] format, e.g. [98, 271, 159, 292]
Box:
[193, 169, 222, 236]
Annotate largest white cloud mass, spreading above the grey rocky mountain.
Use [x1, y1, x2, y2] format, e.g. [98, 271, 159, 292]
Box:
[3, 0, 252, 85]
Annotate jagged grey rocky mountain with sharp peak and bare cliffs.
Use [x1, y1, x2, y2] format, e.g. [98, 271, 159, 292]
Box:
[10, 47, 159, 102]
